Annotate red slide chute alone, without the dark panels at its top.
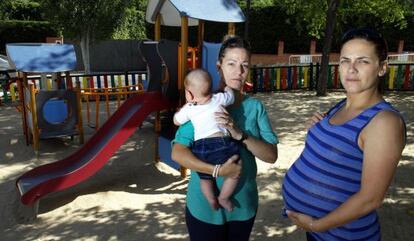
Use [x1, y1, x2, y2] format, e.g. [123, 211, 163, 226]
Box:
[16, 92, 173, 206]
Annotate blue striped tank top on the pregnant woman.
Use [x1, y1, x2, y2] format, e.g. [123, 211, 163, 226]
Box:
[282, 100, 398, 241]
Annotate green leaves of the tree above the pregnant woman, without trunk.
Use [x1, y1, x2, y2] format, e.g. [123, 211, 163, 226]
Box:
[274, 0, 407, 39]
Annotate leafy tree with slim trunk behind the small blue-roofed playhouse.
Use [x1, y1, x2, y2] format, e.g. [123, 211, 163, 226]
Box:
[42, 0, 131, 73]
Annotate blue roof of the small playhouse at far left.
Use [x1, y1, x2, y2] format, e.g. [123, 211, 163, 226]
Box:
[6, 43, 76, 73]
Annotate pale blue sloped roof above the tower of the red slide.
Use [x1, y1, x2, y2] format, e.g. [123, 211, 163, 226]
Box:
[145, 0, 245, 26]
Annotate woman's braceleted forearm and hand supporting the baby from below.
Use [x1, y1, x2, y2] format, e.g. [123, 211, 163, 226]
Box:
[171, 143, 242, 178]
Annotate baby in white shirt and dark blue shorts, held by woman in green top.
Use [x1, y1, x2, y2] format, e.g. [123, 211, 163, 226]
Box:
[174, 69, 240, 211]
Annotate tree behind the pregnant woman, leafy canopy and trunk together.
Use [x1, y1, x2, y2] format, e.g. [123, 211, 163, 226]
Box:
[274, 0, 412, 95]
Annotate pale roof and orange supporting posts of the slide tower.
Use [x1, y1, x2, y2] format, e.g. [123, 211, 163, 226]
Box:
[145, 0, 245, 85]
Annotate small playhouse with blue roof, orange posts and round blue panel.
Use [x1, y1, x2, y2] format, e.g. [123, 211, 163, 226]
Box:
[6, 44, 83, 152]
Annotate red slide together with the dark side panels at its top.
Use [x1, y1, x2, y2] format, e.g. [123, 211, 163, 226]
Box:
[16, 38, 178, 208]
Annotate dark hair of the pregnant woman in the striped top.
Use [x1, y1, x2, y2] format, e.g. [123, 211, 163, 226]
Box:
[341, 27, 388, 61]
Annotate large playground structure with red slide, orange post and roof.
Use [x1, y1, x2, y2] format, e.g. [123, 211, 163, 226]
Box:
[11, 1, 244, 210]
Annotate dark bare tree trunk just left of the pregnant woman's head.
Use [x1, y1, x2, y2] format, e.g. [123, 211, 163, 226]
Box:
[316, 0, 339, 96]
